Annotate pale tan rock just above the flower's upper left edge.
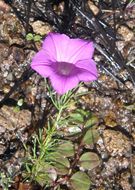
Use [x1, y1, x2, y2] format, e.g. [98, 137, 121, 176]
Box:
[31, 20, 52, 36]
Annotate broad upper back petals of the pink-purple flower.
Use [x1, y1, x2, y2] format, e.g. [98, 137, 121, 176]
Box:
[43, 33, 94, 63]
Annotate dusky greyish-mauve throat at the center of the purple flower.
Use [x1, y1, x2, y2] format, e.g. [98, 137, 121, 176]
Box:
[57, 62, 74, 76]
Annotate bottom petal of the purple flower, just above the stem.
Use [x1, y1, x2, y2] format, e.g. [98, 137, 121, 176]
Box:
[50, 74, 79, 95]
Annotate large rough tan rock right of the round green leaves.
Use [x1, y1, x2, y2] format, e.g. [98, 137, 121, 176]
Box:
[103, 130, 131, 156]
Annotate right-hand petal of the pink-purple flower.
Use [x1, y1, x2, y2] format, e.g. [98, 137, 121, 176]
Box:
[75, 59, 98, 79]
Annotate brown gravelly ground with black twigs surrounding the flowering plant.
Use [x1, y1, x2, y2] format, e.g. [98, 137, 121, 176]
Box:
[0, 0, 135, 190]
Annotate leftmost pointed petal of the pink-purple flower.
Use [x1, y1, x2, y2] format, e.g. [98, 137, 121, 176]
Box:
[31, 50, 54, 77]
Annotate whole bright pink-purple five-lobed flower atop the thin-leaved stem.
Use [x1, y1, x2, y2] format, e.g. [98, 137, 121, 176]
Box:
[31, 33, 98, 95]
